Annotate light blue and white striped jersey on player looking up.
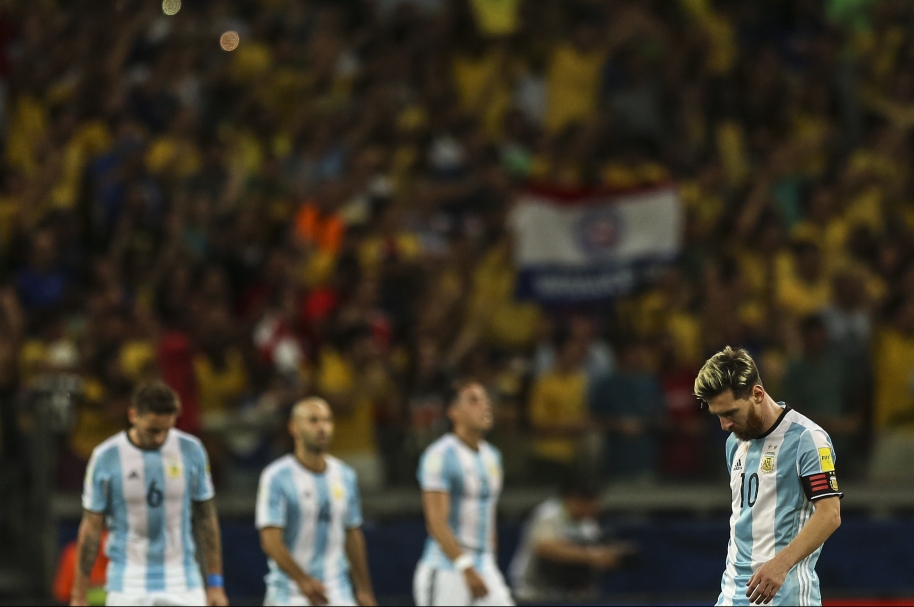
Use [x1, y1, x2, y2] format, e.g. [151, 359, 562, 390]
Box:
[418, 433, 504, 569]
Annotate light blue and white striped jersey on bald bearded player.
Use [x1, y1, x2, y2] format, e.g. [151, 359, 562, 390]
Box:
[256, 454, 362, 604]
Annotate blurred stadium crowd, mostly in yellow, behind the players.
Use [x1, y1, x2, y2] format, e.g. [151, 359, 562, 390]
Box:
[0, 0, 914, 604]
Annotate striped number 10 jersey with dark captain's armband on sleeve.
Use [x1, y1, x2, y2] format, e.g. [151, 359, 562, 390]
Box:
[717, 403, 843, 605]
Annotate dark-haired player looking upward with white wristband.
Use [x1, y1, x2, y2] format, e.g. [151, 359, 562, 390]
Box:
[413, 381, 514, 606]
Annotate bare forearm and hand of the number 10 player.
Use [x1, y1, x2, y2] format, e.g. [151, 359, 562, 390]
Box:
[746, 496, 841, 604]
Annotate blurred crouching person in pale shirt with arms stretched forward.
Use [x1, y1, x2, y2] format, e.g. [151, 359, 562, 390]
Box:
[510, 476, 636, 603]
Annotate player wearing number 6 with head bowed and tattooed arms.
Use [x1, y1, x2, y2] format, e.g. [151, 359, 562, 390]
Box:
[70, 382, 228, 605]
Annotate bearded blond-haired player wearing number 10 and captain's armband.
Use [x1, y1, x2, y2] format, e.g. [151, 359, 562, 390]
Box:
[695, 347, 843, 605]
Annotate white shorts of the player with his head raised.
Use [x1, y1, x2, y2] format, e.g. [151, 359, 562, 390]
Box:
[413, 556, 514, 607]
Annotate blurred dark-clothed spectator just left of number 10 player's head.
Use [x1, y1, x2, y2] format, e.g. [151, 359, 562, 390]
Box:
[590, 341, 666, 480]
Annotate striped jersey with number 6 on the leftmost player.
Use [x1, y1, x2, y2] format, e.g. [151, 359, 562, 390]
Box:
[82, 430, 215, 592]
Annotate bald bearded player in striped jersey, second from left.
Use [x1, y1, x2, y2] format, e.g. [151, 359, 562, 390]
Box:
[256, 398, 377, 605]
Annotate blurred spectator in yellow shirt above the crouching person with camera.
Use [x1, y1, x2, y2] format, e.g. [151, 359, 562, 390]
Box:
[528, 334, 590, 481]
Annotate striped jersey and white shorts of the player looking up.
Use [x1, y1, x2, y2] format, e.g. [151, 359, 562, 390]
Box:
[413, 434, 514, 605]
